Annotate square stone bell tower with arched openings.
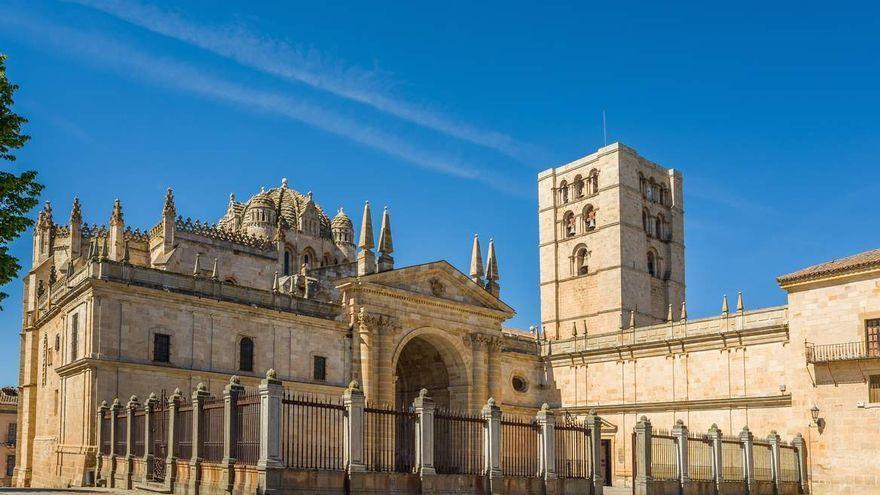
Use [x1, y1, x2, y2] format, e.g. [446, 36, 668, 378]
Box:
[538, 143, 685, 340]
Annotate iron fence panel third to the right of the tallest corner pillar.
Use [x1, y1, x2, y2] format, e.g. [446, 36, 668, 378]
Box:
[434, 408, 486, 474]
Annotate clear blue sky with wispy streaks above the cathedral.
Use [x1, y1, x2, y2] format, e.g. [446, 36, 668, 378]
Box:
[0, 0, 880, 383]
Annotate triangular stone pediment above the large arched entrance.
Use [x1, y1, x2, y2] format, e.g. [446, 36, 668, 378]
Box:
[336, 261, 514, 316]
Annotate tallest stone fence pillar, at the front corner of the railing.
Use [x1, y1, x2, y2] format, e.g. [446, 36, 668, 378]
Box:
[257, 369, 284, 495]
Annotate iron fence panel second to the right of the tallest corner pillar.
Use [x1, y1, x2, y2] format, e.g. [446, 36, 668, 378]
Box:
[363, 405, 416, 473]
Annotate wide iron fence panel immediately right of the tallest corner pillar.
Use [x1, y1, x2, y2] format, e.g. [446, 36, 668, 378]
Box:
[281, 392, 345, 471]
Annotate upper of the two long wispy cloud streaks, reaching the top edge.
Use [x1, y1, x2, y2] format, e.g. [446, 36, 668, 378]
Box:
[68, 0, 534, 160]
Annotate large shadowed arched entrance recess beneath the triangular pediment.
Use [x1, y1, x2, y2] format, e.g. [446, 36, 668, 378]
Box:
[394, 335, 468, 409]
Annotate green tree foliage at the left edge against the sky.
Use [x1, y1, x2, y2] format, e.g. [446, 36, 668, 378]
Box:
[0, 54, 43, 309]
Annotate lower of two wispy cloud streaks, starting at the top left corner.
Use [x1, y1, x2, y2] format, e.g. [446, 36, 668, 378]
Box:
[0, 10, 522, 195]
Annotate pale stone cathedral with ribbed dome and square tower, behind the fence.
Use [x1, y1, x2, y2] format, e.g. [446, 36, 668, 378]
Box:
[14, 143, 880, 493]
